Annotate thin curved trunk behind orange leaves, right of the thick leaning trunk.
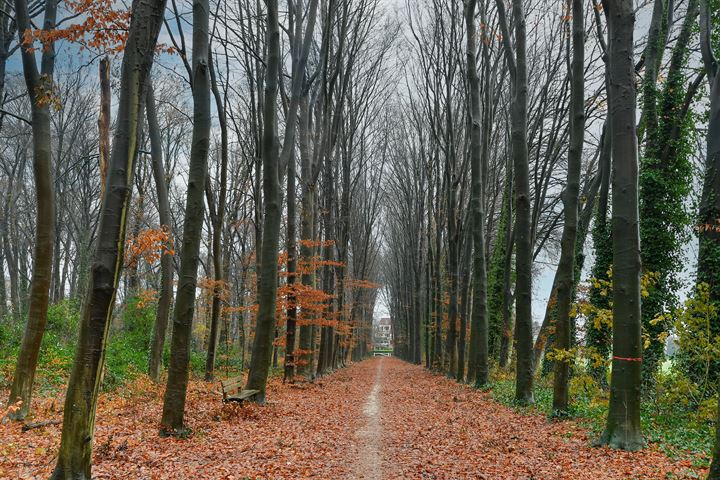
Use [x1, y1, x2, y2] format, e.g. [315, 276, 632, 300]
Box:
[145, 82, 173, 382]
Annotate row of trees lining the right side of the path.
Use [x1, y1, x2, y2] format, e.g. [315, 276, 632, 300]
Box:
[383, 0, 720, 472]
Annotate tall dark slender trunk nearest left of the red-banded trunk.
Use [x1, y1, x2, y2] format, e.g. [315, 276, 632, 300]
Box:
[553, 0, 585, 416]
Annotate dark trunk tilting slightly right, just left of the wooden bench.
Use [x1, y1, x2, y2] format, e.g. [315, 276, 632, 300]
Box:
[160, 0, 211, 435]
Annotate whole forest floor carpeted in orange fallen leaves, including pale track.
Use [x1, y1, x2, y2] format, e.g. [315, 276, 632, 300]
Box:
[0, 358, 703, 480]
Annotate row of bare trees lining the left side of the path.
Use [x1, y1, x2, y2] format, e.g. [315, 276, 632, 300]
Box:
[0, 0, 399, 479]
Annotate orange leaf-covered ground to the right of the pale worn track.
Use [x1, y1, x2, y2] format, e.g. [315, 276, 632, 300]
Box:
[350, 358, 697, 480]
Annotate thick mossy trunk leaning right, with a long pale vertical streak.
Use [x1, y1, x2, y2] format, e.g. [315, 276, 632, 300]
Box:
[51, 0, 165, 480]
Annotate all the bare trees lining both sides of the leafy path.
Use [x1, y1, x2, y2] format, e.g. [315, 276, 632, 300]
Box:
[0, 0, 720, 478]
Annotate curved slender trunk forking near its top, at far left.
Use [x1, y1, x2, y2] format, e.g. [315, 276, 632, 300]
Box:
[2, 0, 57, 420]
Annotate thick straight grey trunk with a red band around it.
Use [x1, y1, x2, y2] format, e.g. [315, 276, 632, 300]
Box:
[600, 0, 645, 450]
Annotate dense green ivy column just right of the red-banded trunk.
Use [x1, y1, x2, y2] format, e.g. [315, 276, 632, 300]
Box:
[639, 3, 697, 392]
